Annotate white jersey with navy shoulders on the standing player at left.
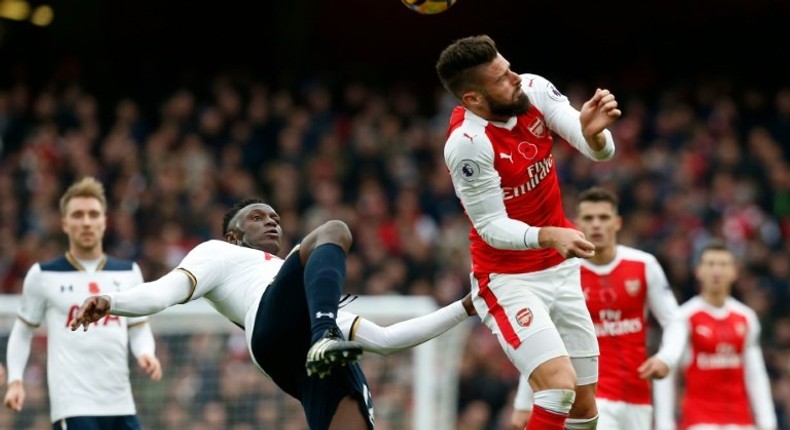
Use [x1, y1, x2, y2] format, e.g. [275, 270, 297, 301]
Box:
[18, 254, 146, 422]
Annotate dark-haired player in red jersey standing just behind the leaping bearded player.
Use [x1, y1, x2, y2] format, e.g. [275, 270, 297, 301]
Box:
[512, 187, 680, 430]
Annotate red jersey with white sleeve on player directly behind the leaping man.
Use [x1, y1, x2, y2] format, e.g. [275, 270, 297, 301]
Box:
[581, 245, 679, 405]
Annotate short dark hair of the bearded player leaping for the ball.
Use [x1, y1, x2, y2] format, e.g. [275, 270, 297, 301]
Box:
[436, 35, 499, 99]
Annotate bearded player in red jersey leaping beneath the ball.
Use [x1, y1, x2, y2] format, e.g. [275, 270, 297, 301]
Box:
[436, 36, 621, 430]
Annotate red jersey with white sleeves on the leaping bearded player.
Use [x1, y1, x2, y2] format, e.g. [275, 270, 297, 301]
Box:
[444, 74, 614, 274]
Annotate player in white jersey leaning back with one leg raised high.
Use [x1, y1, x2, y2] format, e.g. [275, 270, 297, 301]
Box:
[72, 199, 474, 430]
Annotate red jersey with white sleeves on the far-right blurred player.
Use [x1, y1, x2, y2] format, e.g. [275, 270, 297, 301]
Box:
[656, 297, 776, 430]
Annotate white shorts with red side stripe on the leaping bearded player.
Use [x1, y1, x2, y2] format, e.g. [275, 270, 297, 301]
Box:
[471, 258, 599, 385]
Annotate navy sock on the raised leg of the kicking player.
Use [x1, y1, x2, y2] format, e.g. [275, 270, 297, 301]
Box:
[304, 243, 346, 344]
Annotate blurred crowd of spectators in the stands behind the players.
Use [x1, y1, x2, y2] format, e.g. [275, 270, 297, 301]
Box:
[0, 61, 790, 430]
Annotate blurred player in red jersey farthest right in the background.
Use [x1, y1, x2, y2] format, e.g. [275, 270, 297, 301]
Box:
[655, 242, 777, 430]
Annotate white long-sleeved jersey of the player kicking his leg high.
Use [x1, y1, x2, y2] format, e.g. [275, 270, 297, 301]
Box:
[110, 240, 474, 373]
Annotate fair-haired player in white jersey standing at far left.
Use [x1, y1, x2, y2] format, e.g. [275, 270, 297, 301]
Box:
[4, 177, 162, 430]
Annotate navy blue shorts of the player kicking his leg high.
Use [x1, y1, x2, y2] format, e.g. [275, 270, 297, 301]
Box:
[252, 252, 374, 430]
